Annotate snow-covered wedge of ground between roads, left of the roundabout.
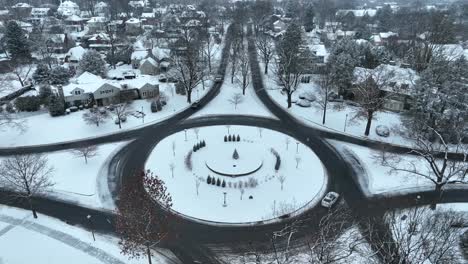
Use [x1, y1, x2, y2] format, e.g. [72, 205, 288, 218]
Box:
[0, 142, 128, 210]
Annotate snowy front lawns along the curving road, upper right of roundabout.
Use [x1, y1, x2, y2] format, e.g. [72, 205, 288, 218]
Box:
[261, 63, 410, 145]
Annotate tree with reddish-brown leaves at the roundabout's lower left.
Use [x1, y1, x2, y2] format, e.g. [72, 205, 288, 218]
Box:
[116, 171, 175, 264]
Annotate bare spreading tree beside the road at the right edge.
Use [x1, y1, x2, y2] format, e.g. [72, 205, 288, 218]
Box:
[376, 128, 468, 208]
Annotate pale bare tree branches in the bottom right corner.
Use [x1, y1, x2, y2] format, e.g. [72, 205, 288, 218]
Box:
[369, 207, 463, 264]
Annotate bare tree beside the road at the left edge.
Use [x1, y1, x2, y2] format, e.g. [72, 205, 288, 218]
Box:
[0, 154, 54, 218]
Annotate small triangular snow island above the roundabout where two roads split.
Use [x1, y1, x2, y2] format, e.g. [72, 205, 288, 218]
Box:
[190, 77, 275, 118]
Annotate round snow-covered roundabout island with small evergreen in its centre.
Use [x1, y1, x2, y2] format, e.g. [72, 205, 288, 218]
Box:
[146, 126, 328, 224]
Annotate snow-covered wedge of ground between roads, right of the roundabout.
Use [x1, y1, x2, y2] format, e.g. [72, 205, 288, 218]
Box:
[329, 140, 464, 196]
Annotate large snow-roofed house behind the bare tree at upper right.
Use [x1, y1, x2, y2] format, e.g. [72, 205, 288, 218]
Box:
[353, 64, 419, 112]
